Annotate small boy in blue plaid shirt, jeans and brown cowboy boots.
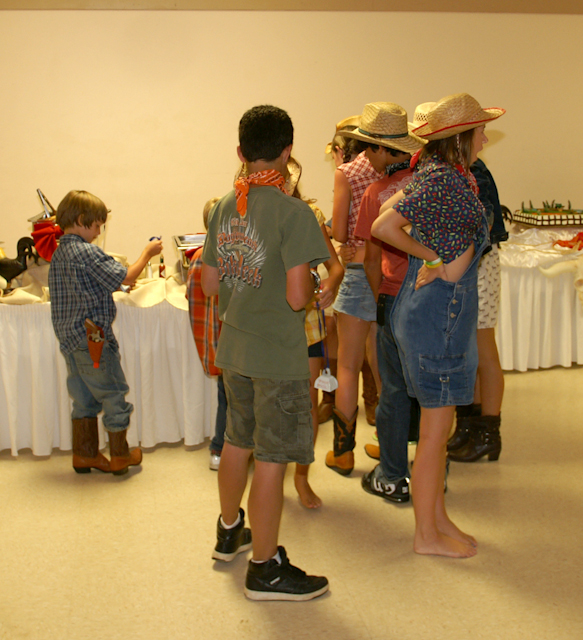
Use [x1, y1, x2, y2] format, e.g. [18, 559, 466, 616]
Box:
[49, 191, 162, 475]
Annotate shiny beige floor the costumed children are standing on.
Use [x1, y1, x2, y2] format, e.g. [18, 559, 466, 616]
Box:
[0, 368, 583, 640]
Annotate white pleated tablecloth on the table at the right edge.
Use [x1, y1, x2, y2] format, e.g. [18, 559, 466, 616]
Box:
[496, 227, 583, 371]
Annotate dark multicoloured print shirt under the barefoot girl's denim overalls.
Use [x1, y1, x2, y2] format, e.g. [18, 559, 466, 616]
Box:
[394, 155, 487, 264]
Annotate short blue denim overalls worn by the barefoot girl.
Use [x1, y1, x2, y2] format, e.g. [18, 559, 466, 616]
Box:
[391, 220, 490, 409]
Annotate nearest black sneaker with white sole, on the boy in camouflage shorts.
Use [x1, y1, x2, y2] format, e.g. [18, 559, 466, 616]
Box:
[245, 547, 328, 602]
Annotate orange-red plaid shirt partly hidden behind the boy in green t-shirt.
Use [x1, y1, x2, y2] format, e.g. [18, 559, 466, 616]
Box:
[186, 247, 221, 376]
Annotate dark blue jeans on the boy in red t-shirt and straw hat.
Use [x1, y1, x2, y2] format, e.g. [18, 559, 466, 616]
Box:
[376, 295, 420, 482]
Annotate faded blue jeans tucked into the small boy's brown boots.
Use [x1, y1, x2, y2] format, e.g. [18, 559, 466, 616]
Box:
[65, 340, 134, 431]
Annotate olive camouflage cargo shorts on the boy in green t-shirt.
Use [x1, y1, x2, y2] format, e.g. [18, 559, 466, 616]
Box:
[223, 369, 314, 464]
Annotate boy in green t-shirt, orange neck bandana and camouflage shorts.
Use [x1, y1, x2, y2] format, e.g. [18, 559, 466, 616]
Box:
[202, 106, 329, 600]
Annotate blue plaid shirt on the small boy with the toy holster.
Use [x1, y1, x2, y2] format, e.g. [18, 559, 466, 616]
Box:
[49, 233, 127, 354]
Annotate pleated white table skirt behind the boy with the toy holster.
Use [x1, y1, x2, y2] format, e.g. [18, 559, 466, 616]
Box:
[0, 300, 217, 455]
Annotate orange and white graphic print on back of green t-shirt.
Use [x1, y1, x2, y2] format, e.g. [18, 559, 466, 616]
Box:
[217, 217, 267, 291]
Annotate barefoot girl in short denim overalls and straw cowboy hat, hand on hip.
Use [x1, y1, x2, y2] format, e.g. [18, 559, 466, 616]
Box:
[372, 93, 504, 558]
